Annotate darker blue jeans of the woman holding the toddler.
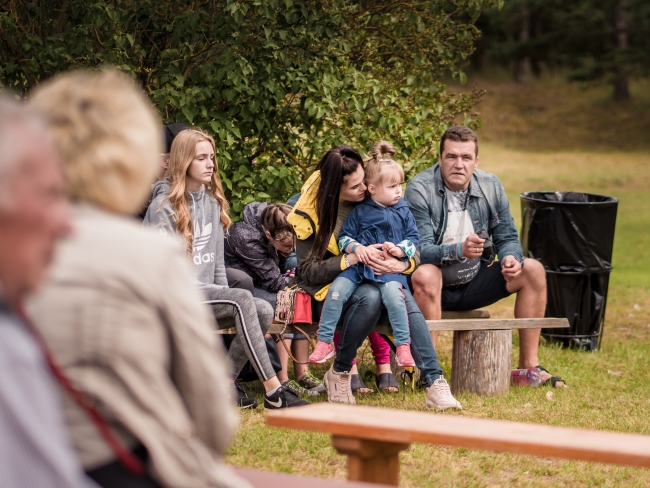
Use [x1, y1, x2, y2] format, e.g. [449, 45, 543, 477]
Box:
[314, 283, 442, 387]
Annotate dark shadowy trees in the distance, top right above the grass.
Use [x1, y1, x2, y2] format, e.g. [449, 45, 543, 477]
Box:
[480, 0, 650, 100]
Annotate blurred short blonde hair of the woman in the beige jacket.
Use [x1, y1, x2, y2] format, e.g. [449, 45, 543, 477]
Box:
[30, 70, 163, 213]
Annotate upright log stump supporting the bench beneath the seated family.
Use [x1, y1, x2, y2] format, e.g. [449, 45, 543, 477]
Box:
[451, 329, 512, 396]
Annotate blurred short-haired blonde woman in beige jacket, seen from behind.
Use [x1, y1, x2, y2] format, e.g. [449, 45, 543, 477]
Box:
[30, 71, 248, 488]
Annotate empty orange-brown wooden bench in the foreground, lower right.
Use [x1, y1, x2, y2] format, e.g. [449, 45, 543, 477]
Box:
[266, 403, 650, 486]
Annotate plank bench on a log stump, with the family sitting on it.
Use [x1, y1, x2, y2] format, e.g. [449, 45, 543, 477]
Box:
[211, 310, 569, 396]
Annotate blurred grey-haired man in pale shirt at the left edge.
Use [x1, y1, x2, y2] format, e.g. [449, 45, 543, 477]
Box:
[0, 96, 96, 488]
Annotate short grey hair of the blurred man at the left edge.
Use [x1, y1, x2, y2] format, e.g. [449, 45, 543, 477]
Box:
[0, 93, 47, 208]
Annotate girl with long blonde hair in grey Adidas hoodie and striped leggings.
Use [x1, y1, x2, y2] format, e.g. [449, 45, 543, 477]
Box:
[143, 129, 307, 409]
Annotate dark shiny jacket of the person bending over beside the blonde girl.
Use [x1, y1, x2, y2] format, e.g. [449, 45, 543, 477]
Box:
[224, 202, 290, 292]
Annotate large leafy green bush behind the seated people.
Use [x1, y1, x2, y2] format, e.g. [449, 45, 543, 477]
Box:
[0, 0, 498, 214]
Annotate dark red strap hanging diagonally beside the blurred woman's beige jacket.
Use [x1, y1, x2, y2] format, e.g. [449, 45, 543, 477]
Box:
[17, 305, 146, 476]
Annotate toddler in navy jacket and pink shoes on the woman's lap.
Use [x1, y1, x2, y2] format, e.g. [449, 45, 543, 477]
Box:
[309, 141, 420, 366]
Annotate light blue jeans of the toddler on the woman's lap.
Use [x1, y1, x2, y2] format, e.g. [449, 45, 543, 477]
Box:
[318, 276, 410, 346]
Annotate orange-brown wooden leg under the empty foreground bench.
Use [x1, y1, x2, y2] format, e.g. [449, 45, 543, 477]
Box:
[332, 435, 410, 486]
